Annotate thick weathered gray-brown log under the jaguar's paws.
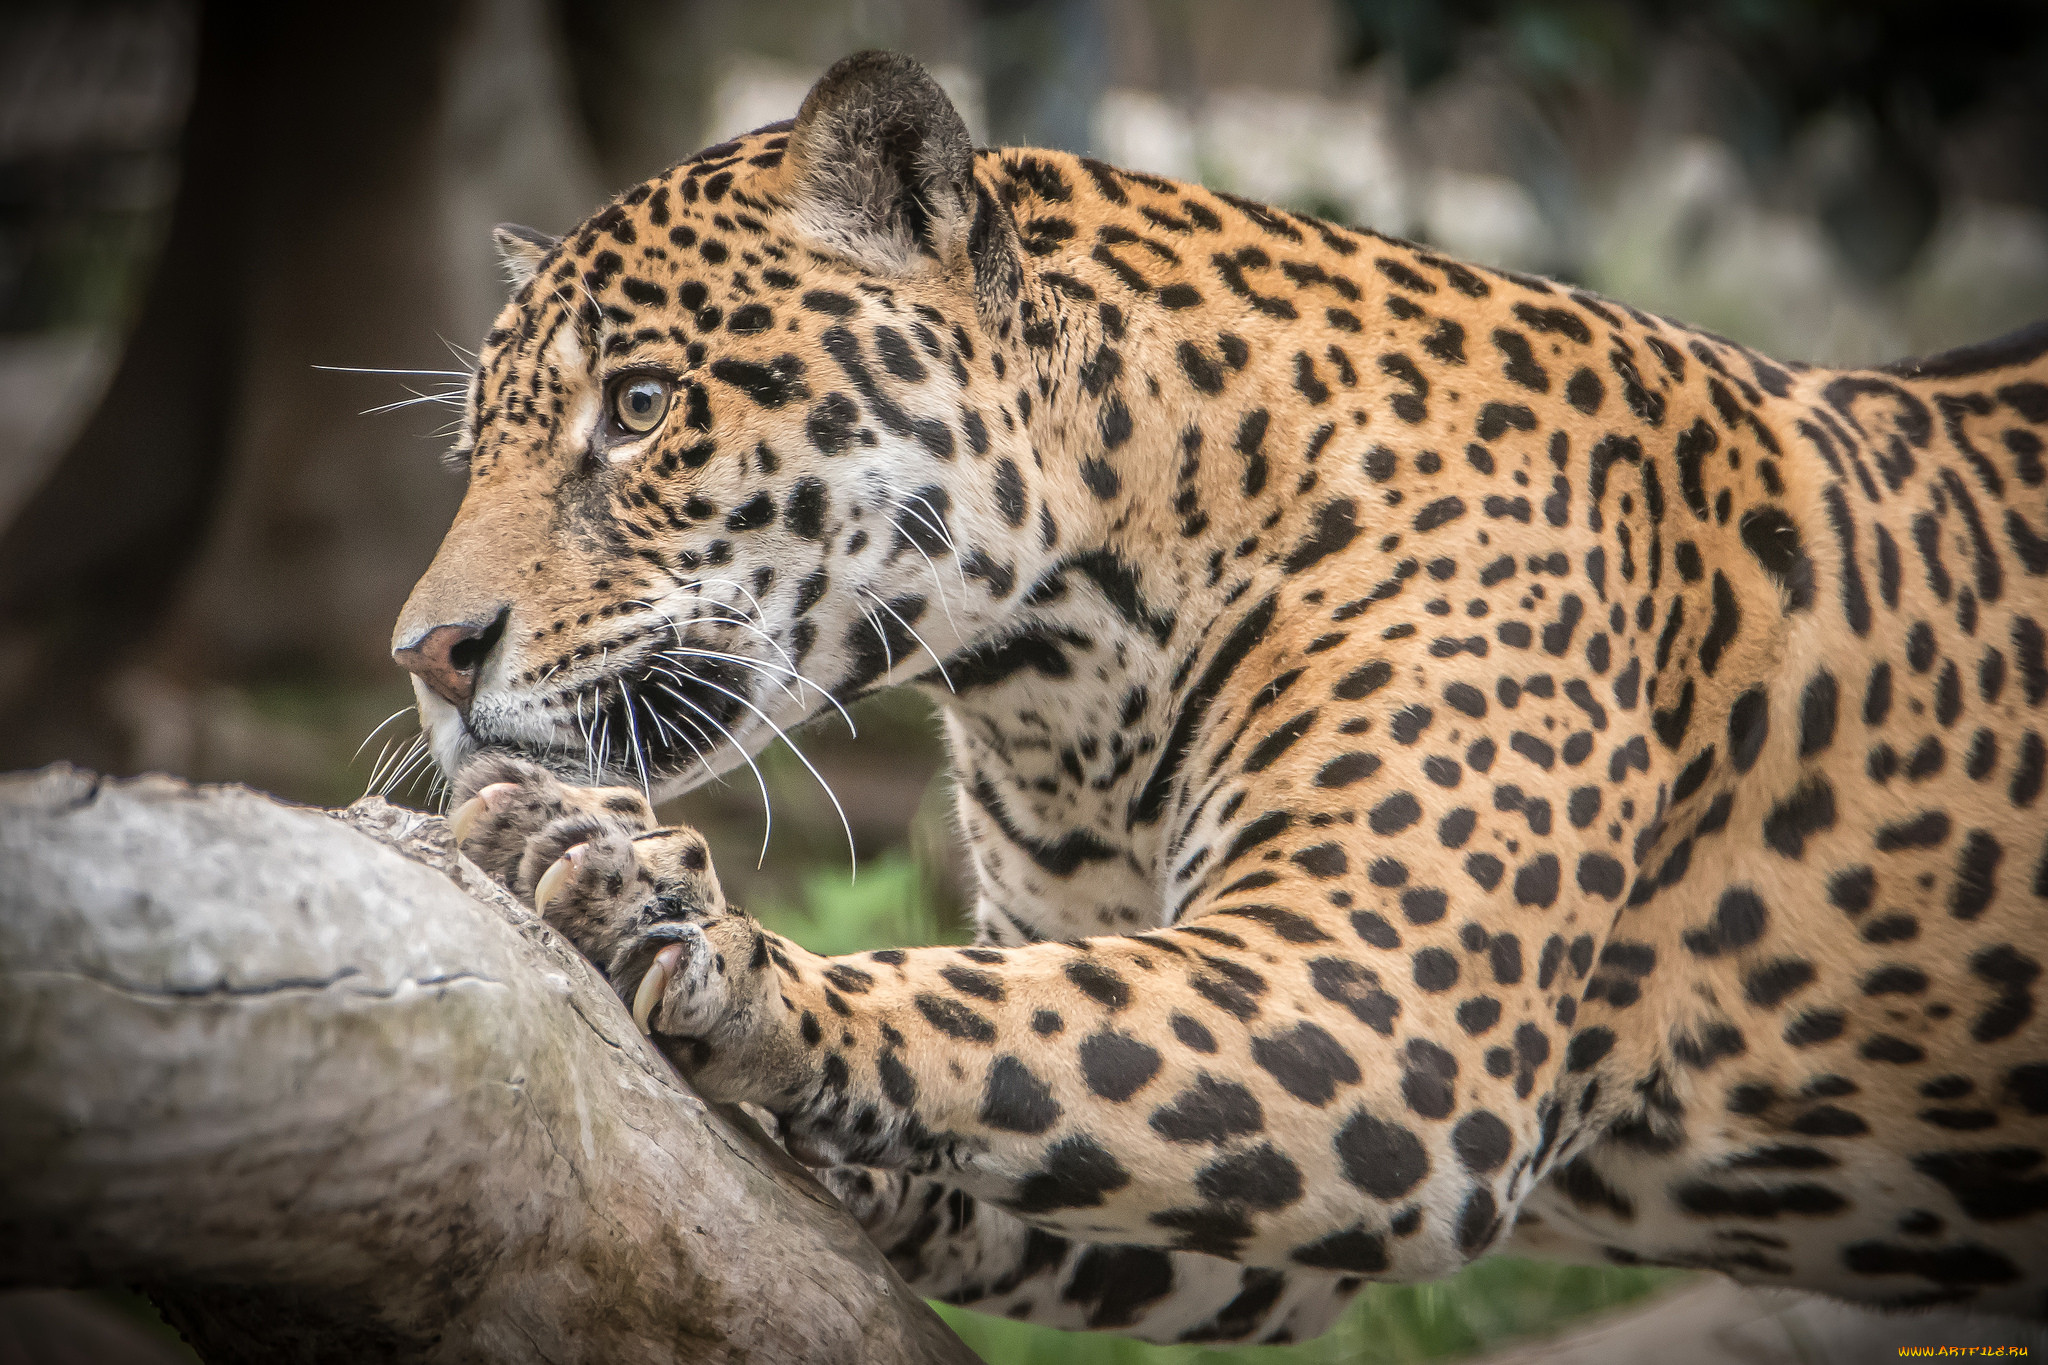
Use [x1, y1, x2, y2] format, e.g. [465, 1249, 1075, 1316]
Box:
[0, 767, 975, 1363]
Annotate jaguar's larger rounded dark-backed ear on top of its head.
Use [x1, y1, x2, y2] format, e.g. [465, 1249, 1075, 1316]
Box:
[786, 51, 1018, 309]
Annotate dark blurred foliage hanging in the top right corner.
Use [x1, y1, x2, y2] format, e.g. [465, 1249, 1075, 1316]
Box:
[1341, 0, 2048, 280]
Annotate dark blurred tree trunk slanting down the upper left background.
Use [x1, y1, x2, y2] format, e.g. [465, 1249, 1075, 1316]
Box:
[0, 0, 457, 767]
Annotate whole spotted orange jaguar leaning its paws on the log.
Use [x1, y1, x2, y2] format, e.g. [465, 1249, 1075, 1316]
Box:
[393, 53, 2048, 1342]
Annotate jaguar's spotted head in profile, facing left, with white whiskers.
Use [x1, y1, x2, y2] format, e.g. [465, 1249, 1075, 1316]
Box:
[393, 53, 1042, 798]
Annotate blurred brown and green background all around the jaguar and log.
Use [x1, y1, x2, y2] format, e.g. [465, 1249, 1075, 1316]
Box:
[0, 0, 2048, 1365]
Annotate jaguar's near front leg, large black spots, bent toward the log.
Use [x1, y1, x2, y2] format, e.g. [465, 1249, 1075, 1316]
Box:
[520, 845, 1563, 1301]
